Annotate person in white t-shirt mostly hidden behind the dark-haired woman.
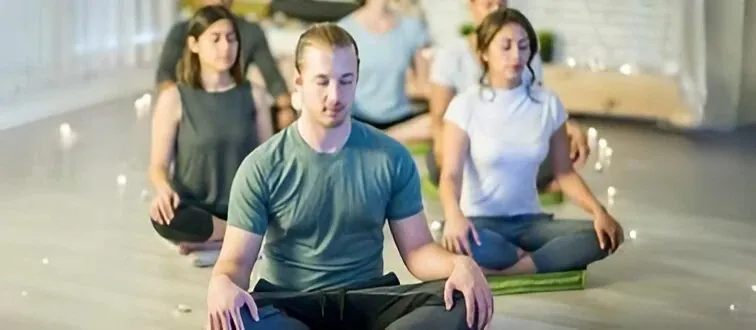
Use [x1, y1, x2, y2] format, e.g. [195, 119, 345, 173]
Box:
[426, 0, 590, 199]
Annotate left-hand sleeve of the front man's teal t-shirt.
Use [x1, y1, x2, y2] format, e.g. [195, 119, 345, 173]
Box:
[228, 152, 270, 236]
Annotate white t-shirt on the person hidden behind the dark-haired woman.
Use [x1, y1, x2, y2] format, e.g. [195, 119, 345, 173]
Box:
[430, 38, 543, 93]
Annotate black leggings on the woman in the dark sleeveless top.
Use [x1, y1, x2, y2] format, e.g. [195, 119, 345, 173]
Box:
[150, 203, 226, 243]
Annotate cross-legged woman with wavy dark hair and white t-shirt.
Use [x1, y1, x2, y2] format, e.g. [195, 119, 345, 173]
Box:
[440, 9, 624, 275]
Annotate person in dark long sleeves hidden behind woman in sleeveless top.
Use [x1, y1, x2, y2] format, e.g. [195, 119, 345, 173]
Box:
[156, 0, 296, 129]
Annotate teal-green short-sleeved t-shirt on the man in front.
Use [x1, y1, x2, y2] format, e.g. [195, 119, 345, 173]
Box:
[228, 121, 423, 291]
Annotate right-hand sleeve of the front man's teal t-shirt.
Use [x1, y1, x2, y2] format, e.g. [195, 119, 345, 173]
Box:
[386, 144, 423, 221]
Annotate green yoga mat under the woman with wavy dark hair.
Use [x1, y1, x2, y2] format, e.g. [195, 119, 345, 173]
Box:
[487, 270, 587, 296]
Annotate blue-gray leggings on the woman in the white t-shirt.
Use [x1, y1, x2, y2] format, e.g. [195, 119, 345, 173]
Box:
[470, 214, 608, 273]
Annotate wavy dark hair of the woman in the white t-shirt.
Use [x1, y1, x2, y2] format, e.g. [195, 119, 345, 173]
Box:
[475, 8, 538, 102]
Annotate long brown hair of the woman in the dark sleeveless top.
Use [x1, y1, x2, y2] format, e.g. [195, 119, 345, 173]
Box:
[176, 5, 244, 89]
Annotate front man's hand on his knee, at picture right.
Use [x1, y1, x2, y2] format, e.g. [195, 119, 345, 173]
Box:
[444, 257, 493, 329]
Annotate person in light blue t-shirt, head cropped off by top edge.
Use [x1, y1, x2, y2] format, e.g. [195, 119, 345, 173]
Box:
[339, 0, 430, 144]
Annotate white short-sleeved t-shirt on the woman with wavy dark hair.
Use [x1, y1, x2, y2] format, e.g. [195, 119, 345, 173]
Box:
[444, 84, 567, 217]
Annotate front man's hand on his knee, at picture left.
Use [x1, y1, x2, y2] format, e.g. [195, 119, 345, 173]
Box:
[205, 275, 260, 330]
